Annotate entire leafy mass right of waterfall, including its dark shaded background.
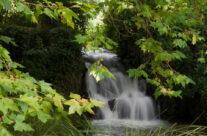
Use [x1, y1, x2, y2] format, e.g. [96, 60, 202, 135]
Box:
[76, 0, 207, 123]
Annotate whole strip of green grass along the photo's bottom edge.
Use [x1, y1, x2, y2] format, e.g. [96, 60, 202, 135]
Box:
[15, 116, 207, 136]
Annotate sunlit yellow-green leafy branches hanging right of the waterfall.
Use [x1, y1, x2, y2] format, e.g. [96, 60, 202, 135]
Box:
[99, 0, 205, 98]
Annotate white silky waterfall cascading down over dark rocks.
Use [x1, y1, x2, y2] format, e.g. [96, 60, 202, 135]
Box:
[84, 49, 160, 127]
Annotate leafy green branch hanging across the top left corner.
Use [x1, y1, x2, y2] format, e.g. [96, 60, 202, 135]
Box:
[0, 0, 93, 28]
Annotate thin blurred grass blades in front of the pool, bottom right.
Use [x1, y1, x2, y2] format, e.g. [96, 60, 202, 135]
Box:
[91, 121, 207, 136]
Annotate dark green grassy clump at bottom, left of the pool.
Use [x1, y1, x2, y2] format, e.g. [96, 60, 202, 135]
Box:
[16, 115, 93, 136]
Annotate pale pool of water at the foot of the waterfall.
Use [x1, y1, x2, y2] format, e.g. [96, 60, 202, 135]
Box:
[92, 119, 164, 136]
